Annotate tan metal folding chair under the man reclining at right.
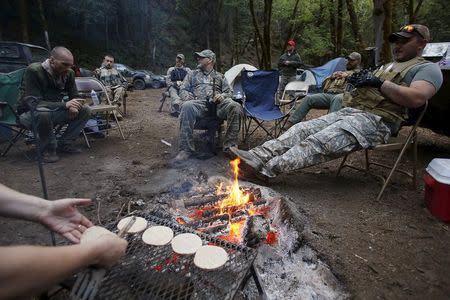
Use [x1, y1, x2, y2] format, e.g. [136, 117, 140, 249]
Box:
[336, 102, 428, 200]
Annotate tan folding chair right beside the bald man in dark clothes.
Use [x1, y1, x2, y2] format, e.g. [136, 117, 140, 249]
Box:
[75, 77, 125, 148]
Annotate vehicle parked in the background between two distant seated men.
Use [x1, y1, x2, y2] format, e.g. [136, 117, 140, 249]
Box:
[114, 63, 165, 90]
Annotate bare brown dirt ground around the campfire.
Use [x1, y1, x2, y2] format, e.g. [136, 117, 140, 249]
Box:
[0, 89, 450, 299]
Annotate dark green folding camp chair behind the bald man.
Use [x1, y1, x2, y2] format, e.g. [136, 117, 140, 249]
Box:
[0, 68, 28, 156]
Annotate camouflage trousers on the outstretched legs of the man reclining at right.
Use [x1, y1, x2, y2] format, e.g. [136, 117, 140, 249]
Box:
[250, 108, 391, 174]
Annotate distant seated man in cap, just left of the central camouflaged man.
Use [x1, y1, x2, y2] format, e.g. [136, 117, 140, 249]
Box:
[166, 54, 190, 116]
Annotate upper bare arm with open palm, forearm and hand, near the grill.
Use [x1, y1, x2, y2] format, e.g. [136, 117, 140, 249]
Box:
[0, 184, 92, 243]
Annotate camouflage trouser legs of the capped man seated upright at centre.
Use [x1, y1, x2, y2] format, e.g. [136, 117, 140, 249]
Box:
[179, 98, 243, 152]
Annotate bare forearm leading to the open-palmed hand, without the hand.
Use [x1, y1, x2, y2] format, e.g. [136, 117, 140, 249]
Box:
[0, 184, 49, 221]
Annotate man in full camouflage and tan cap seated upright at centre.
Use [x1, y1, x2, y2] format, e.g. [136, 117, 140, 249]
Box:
[175, 49, 243, 162]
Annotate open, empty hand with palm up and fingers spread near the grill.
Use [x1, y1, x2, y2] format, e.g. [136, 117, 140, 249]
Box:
[38, 198, 93, 243]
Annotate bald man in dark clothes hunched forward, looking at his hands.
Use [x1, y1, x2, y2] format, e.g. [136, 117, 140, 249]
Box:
[17, 47, 90, 162]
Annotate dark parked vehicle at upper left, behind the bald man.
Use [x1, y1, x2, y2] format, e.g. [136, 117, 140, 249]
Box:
[0, 41, 49, 73]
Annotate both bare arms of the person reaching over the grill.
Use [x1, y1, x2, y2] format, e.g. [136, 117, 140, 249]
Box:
[0, 184, 128, 299]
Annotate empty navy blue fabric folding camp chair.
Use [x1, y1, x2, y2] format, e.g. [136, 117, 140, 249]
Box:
[241, 70, 293, 142]
